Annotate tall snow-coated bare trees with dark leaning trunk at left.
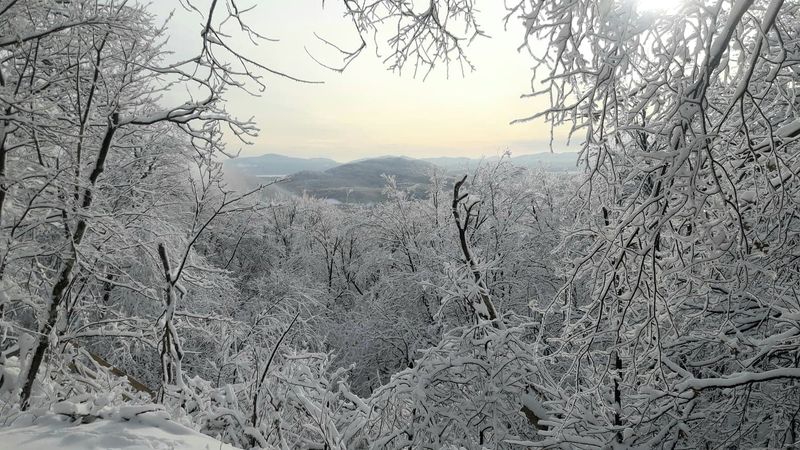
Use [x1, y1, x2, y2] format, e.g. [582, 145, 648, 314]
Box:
[0, 0, 291, 407]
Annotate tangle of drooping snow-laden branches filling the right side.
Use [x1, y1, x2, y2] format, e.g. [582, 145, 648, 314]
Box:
[511, 0, 800, 446]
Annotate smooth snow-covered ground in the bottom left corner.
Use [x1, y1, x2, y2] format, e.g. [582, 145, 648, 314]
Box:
[0, 415, 235, 450]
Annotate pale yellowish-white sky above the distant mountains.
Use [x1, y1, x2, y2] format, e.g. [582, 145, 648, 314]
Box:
[158, 0, 566, 161]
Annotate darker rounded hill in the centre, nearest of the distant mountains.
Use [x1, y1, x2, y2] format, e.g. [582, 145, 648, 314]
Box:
[281, 156, 436, 203]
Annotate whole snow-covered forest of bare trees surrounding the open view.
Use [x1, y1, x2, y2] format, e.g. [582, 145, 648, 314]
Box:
[0, 0, 800, 450]
